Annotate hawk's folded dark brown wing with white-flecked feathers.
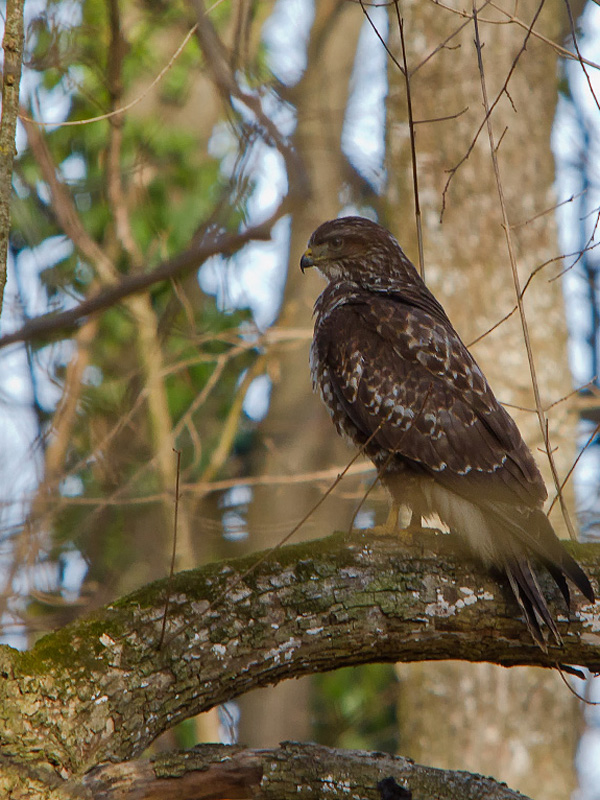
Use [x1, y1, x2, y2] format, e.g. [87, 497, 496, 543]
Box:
[313, 293, 546, 505]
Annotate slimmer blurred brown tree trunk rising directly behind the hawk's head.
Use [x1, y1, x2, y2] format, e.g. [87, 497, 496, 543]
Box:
[240, 0, 363, 746]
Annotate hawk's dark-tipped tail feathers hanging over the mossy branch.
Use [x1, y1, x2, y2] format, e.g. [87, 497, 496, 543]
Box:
[488, 507, 595, 651]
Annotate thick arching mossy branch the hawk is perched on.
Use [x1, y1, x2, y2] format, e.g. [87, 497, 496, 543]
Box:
[0, 532, 600, 773]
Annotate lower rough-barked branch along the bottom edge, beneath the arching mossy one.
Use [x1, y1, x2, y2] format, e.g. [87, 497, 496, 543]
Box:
[79, 742, 526, 800]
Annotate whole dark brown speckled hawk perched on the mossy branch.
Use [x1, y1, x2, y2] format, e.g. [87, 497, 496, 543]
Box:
[300, 217, 594, 650]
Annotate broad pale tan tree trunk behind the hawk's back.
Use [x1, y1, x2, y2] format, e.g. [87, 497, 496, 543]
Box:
[388, 2, 579, 800]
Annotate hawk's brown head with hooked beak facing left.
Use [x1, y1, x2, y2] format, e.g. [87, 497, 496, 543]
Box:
[300, 217, 418, 286]
